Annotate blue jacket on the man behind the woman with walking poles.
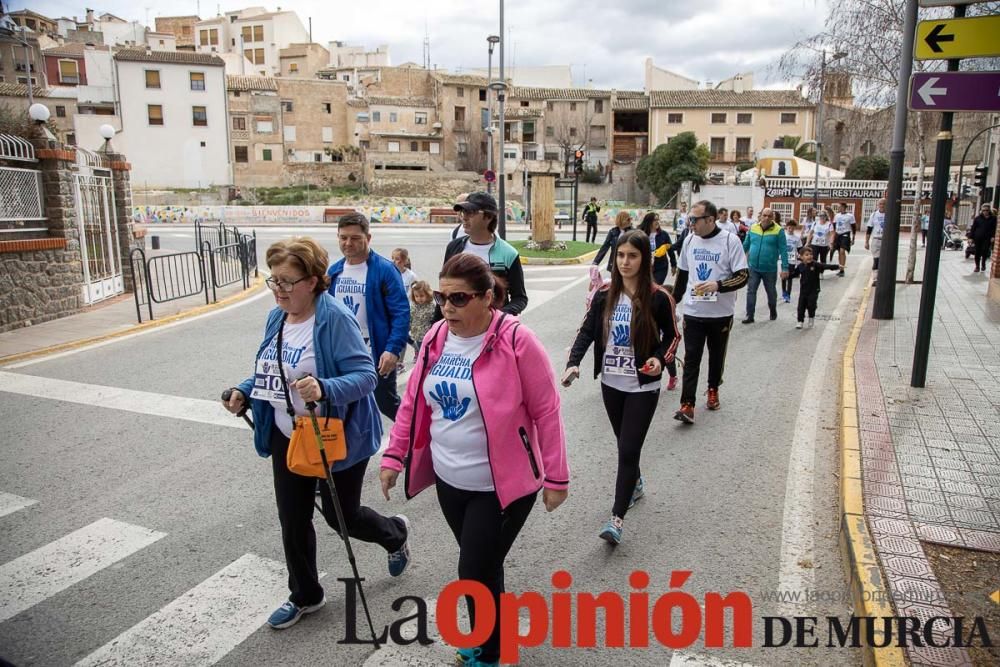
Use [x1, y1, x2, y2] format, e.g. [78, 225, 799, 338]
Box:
[327, 250, 410, 366]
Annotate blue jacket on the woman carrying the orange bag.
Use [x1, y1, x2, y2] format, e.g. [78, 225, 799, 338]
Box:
[238, 294, 382, 470]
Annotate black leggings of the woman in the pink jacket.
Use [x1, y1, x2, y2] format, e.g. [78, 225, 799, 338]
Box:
[436, 478, 538, 662]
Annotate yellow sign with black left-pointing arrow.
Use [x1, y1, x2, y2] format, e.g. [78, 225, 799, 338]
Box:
[913, 15, 1000, 60]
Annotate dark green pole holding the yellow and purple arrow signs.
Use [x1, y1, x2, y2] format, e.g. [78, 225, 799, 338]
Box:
[912, 5, 965, 387]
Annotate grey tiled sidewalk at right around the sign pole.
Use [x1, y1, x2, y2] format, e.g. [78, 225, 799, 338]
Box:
[855, 247, 1000, 665]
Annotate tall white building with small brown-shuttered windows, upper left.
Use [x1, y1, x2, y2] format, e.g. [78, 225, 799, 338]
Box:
[114, 49, 233, 188]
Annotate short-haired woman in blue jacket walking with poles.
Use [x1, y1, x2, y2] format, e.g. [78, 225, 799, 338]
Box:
[224, 237, 410, 629]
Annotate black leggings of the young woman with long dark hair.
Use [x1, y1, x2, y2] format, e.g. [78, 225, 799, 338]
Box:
[601, 382, 660, 518]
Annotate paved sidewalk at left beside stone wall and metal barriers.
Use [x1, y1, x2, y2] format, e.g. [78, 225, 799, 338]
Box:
[0, 276, 263, 364]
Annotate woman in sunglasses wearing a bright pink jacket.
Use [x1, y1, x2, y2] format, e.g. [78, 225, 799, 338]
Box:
[381, 253, 569, 665]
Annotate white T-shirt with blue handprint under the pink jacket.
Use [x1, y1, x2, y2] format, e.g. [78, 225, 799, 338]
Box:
[422, 333, 493, 491]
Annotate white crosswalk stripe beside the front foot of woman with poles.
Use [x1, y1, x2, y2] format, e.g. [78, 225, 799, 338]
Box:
[76, 554, 288, 667]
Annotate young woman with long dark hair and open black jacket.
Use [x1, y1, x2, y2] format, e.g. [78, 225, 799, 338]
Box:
[562, 230, 680, 545]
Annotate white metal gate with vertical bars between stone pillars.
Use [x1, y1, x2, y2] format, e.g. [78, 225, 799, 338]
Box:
[74, 148, 125, 303]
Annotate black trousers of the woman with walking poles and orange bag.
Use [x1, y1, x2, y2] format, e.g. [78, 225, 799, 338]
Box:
[271, 427, 406, 607]
